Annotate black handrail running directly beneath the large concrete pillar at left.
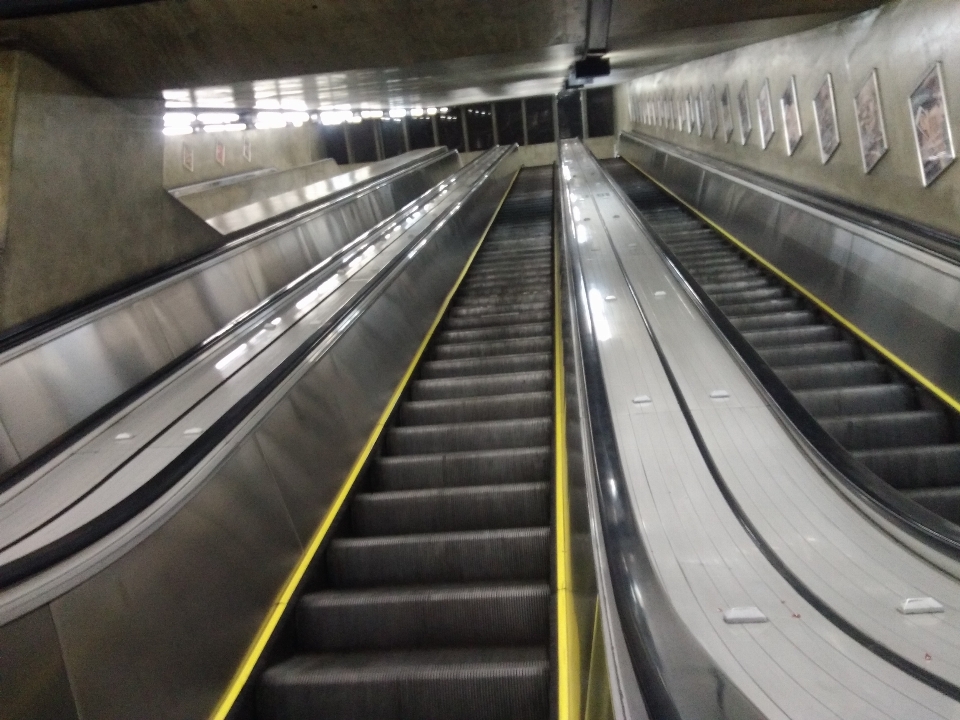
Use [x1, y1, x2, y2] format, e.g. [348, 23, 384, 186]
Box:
[0, 148, 452, 354]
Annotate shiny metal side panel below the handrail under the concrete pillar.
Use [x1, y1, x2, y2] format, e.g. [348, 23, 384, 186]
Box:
[0, 150, 457, 473]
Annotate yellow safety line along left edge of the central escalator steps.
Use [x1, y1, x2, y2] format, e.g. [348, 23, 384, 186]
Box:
[210, 169, 520, 720]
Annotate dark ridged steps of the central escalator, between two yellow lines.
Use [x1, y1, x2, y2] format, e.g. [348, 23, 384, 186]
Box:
[256, 168, 556, 720]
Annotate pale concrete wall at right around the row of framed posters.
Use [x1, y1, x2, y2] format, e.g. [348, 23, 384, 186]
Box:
[630, 0, 960, 240]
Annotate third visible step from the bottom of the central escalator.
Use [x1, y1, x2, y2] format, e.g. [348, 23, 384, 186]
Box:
[326, 527, 550, 588]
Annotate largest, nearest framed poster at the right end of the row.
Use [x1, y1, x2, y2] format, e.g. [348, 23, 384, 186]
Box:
[910, 63, 956, 187]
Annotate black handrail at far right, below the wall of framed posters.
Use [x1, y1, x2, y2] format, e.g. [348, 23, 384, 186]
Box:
[621, 132, 960, 265]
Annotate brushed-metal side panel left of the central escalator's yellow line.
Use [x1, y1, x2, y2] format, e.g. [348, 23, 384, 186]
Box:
[0, 145, 516, 720]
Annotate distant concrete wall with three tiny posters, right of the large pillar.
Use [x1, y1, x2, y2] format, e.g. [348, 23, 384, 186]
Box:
[163, 123, 323, 188]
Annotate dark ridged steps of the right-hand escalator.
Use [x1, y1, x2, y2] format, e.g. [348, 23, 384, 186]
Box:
[604, 160, 960, 523]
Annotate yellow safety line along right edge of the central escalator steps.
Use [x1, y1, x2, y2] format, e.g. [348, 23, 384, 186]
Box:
[553, 198, 580, 720]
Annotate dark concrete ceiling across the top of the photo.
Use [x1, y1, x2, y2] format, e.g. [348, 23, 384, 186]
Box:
[0, 0, 878, 108]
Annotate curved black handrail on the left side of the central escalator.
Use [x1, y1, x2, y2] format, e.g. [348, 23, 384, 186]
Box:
[0, 145, 516, 589]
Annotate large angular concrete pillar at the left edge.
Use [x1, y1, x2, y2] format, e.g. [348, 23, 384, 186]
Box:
[0, 52, 220, 329]
